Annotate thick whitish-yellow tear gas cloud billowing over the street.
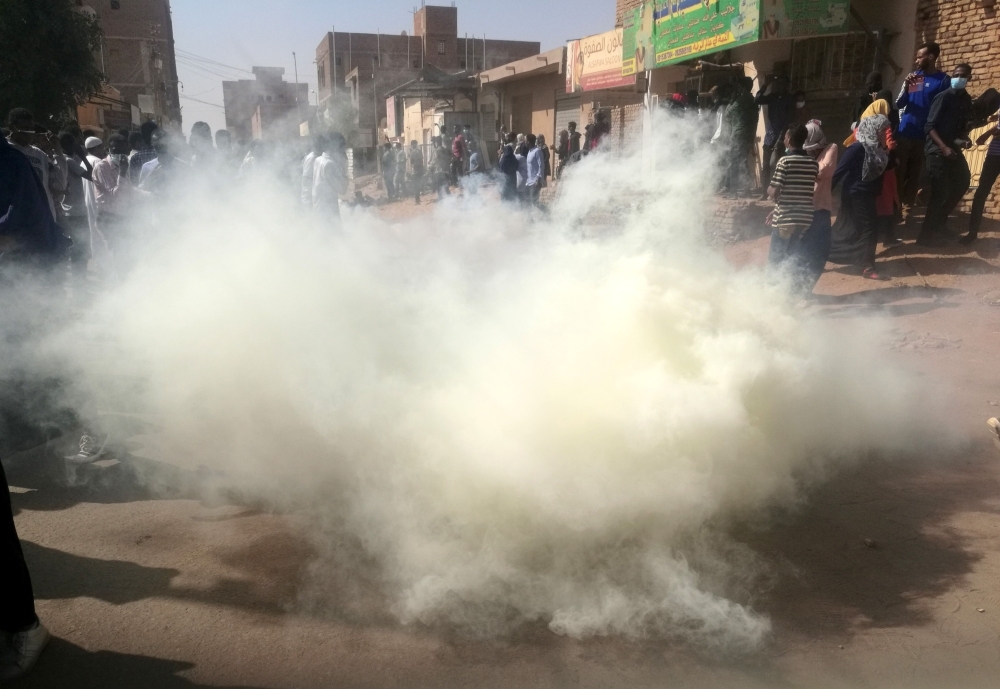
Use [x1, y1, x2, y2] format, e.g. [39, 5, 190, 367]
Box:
[25, 113, 935, 651]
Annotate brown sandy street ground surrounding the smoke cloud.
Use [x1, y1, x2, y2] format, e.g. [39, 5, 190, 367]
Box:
[5, 201, 1000, 689]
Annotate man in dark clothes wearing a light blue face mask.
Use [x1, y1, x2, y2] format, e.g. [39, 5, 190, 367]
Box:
[917, 63, 972, 244]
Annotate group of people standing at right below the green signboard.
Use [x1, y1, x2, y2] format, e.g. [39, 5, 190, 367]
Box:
[710, 42, 1000, 284]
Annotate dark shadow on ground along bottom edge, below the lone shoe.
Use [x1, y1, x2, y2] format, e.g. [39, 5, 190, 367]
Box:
[11, 638, 272, 689]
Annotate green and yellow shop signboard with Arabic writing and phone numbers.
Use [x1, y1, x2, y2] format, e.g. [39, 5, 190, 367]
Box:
[622, 0, 850, 76]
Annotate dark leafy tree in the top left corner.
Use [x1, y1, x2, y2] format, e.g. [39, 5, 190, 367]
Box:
[0, 0, 104, 122]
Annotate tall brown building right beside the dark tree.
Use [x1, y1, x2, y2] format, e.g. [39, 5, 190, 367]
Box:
[76, 0, 181, 130]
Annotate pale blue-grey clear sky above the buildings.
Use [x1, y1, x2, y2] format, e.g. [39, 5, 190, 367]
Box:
[170, 0, 615, 134]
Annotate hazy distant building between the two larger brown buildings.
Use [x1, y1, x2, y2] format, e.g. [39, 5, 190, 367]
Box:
[222, 67, 312, 142]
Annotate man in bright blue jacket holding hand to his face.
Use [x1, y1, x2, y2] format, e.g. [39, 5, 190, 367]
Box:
[896, 43, 951, 222]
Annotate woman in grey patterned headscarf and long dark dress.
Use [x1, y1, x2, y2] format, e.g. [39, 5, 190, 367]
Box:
[829, 115, 889, 280]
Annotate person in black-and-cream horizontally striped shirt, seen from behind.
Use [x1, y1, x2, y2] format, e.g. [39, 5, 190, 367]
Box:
[767, 124, 819, 265]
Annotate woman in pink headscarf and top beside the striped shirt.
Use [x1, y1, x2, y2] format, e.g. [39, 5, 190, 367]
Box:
[798, 120, 839, 292]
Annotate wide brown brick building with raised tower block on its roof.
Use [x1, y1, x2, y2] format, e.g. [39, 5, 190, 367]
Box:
[316, 5, 541, 149]
